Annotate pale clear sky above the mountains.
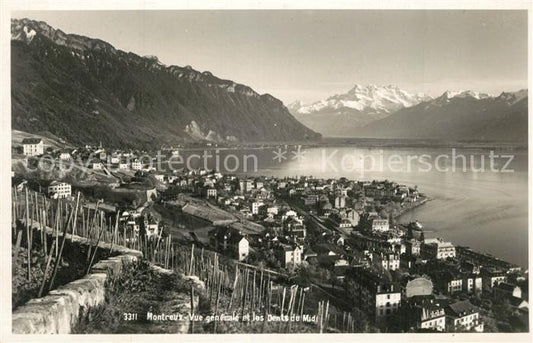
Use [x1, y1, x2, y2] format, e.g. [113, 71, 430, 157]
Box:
[12, 10, 528, 104]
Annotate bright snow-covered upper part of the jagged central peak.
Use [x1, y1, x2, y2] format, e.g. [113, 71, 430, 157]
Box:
[288, 85, 431, 114]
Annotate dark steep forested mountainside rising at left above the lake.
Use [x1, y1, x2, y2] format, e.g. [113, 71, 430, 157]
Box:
[11, 19, 320, 147]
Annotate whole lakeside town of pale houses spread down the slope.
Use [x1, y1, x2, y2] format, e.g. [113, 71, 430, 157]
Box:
[12, 138, 529, 332]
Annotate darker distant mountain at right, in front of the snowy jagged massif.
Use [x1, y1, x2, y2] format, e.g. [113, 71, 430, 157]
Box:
[353, 90, 528, 143]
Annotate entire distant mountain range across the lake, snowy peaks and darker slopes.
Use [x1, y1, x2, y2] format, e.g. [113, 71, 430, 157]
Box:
[288, 85, 528, 143]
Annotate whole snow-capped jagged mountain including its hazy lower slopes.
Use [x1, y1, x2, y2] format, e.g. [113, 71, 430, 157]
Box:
[287, 85, 432, 136]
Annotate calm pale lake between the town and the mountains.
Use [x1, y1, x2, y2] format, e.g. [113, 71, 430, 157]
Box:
[172, 145, 528, 267]
